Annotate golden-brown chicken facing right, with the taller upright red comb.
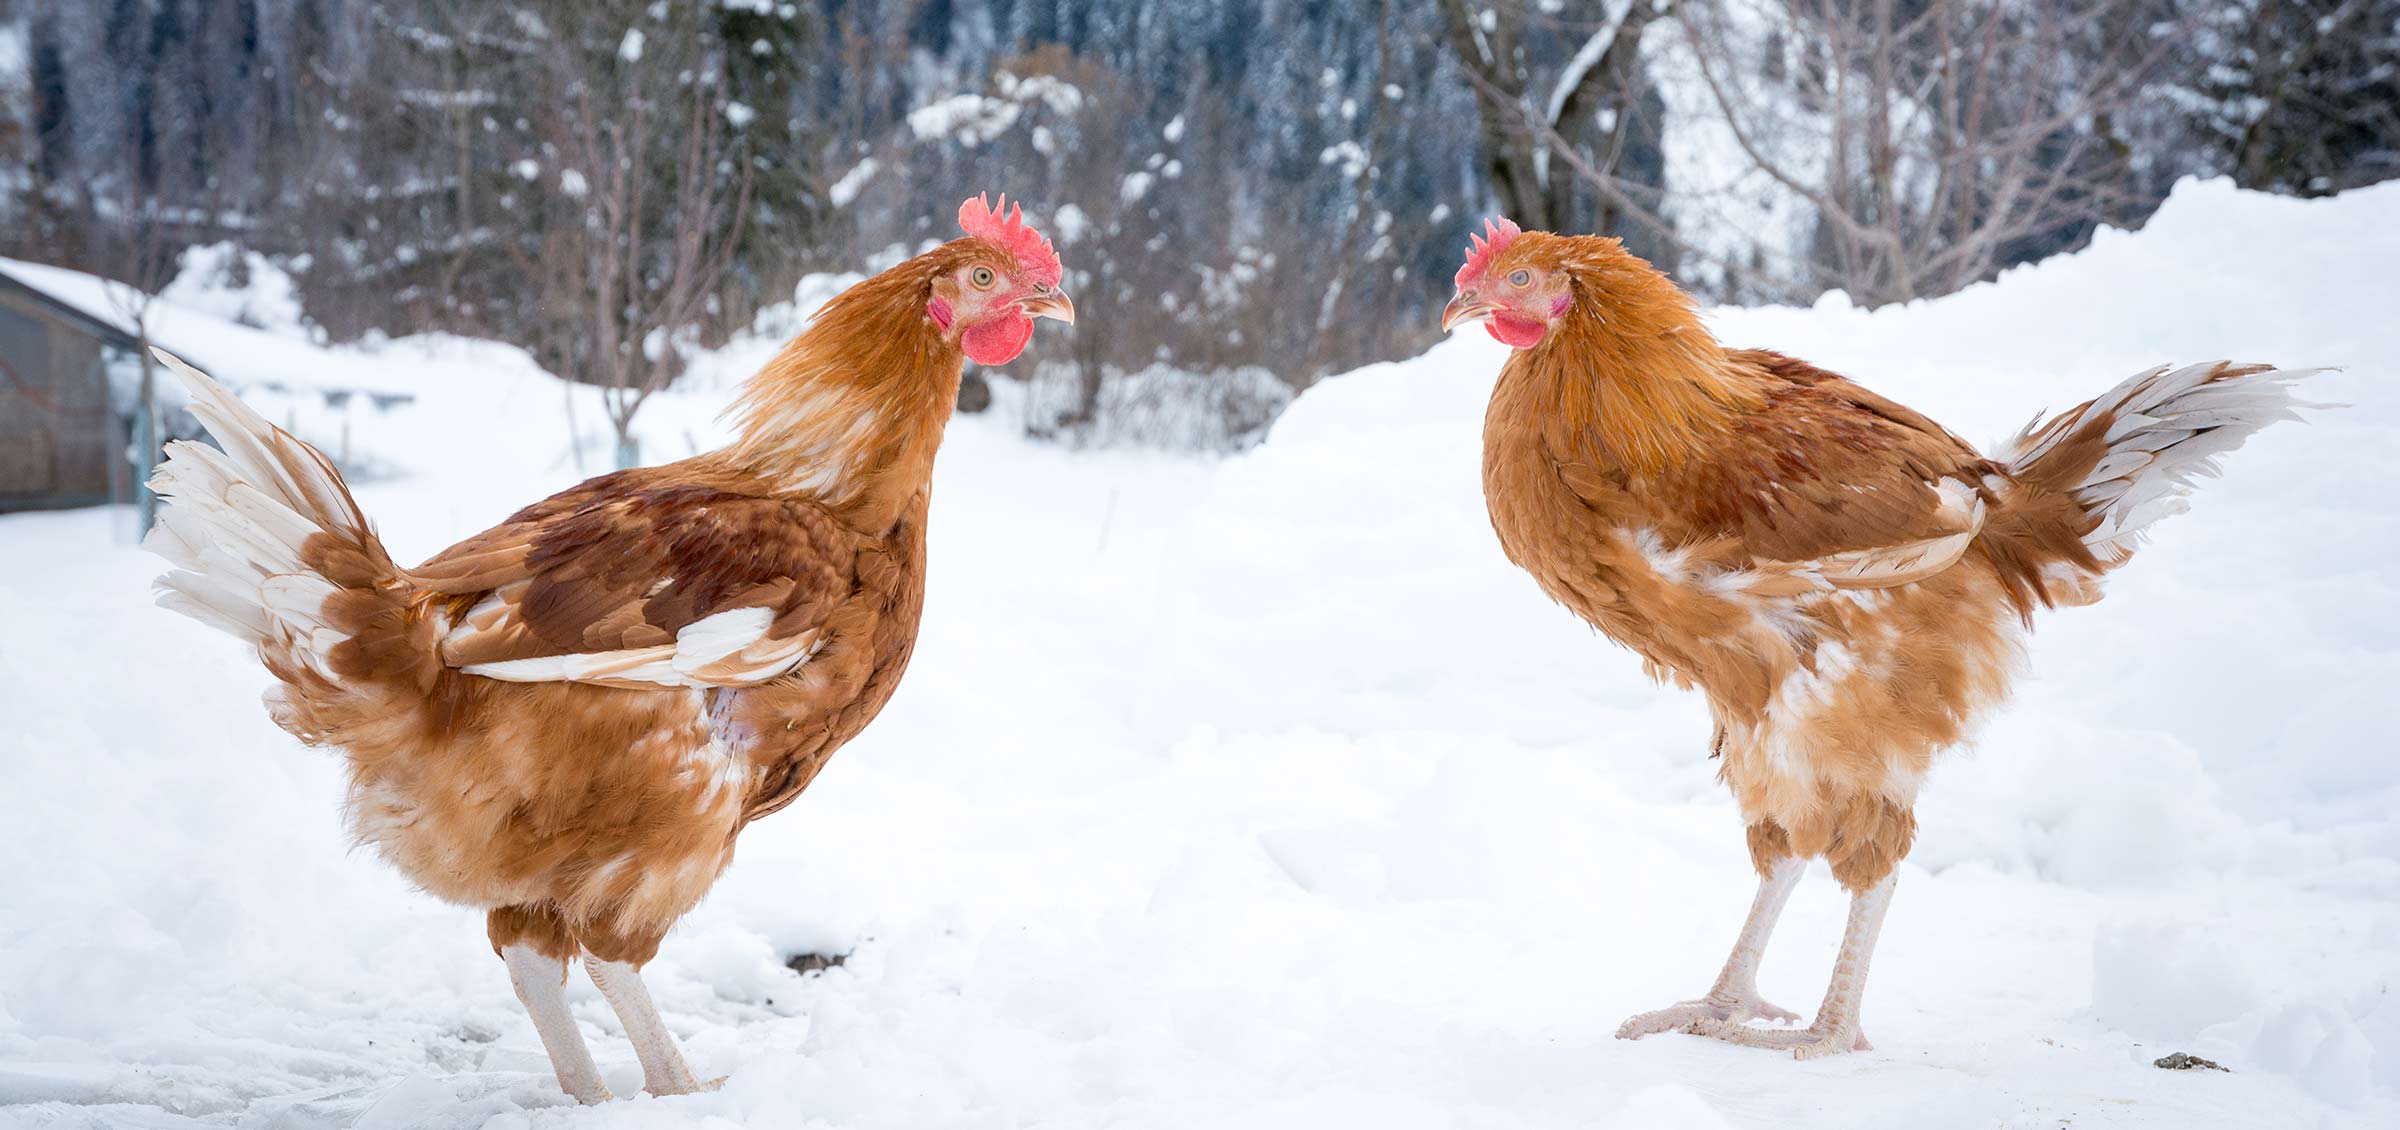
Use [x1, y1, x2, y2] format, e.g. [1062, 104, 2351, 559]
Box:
[149, 197, 1075, 1104]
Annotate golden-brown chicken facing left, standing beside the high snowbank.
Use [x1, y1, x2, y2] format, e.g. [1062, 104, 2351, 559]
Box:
[1442, 221, 2304, 1058]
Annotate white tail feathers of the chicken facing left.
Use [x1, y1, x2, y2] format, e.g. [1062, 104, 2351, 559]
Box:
[2002, 360, 2323, 561]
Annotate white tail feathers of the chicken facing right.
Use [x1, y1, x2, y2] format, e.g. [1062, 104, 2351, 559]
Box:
[142, 340, 372, 669]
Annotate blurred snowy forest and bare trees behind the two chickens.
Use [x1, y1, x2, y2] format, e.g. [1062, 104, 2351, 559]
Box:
[0, 0, 2400, 451]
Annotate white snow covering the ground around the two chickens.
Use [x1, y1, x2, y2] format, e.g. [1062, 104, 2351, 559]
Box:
[0, 185, 2400, 1130]
